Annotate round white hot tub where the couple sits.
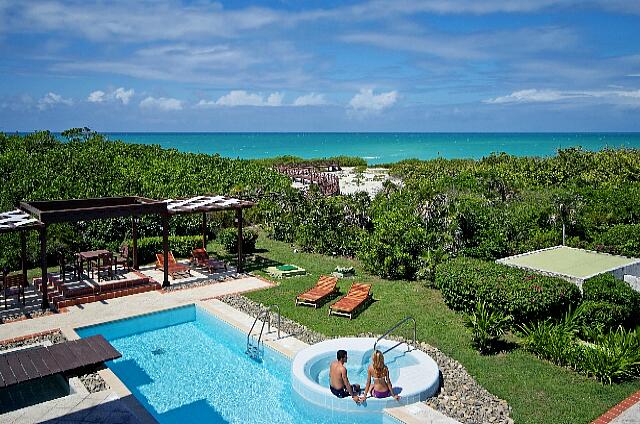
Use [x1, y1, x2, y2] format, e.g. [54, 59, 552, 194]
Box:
[291, 337, 440, 413]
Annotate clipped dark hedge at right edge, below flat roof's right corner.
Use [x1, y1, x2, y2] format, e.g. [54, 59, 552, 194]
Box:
[582, 273, 640, 327]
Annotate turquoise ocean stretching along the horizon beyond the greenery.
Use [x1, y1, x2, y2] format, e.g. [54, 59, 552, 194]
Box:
[104, 133, 640, 165]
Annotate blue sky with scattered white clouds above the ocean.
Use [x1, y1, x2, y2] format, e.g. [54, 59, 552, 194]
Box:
[0, 0, 640, 132]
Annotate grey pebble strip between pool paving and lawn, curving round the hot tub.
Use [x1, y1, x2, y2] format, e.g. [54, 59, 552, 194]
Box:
[220, 295, 513, 424]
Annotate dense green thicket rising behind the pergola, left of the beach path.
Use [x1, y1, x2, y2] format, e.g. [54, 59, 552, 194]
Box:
[0, 130, 290, 269]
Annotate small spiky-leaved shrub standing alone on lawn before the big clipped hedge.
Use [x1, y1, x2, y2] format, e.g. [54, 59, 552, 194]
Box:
[464, 302, 511, 353]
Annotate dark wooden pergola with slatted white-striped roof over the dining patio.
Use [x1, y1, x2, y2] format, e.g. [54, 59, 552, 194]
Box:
[14, 196, 255, 309]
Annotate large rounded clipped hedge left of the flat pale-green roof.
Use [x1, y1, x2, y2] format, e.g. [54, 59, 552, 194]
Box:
[435, 257, 581, 324]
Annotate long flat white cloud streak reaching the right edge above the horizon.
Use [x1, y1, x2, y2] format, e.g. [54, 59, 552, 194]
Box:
[483, 89, 640, 106]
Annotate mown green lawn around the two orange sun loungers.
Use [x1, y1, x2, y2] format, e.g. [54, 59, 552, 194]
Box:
[219, 235, 640, 424]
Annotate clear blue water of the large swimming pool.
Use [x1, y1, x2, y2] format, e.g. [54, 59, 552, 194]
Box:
[76, 305, 388, 424]
